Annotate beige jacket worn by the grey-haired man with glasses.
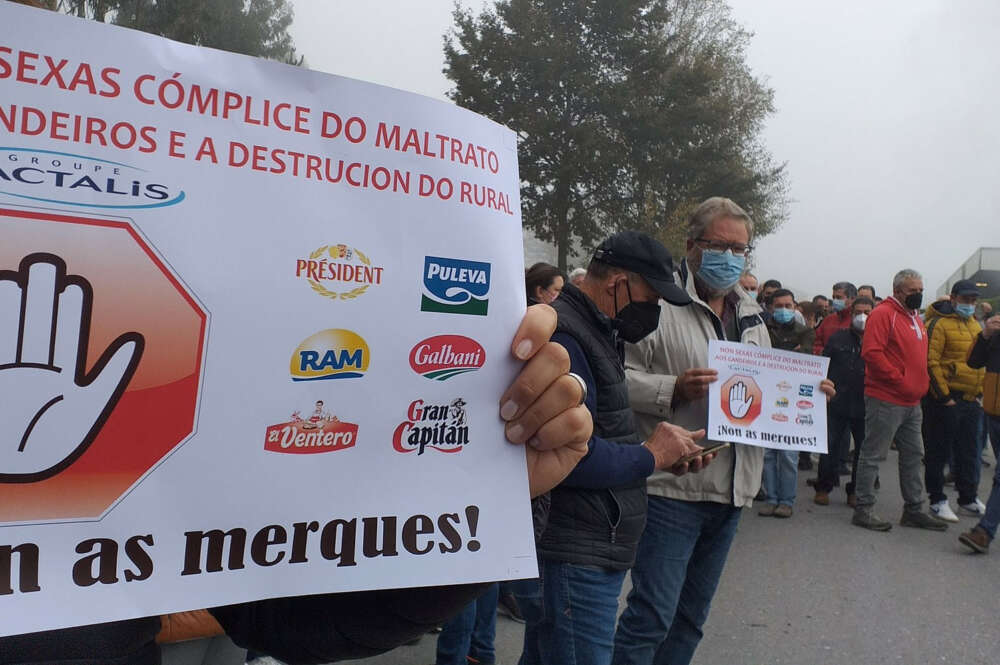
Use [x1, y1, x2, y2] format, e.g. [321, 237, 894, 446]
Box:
[625, 268, 771, 507]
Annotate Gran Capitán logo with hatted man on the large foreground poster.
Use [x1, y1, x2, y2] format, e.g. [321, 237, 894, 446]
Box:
[392, 397, 469, 455]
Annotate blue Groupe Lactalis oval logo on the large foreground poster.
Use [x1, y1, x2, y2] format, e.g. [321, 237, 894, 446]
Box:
[0, 147, 184, 209]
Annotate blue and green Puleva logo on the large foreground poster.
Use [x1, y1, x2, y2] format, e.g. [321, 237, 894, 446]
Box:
[420, 256, 490, 316]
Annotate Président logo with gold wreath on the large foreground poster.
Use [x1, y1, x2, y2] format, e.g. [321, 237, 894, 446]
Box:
[295, 244, 385, 300]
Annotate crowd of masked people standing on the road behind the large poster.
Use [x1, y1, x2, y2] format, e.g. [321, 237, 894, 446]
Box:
[437, 198, 1000, 665]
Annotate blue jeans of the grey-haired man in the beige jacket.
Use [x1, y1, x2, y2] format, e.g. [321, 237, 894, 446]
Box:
[613, 496, 744, 665]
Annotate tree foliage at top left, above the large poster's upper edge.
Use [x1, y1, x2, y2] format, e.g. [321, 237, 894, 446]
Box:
[58, 0, 303, 65]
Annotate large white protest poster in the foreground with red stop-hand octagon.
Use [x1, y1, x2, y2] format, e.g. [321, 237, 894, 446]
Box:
[0, 2, 536, 635]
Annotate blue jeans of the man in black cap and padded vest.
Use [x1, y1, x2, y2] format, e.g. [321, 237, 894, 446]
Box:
[511, 561, 625, 665]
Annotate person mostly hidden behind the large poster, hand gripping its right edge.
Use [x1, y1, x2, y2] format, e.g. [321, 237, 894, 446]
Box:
[0, 305, 593, 665]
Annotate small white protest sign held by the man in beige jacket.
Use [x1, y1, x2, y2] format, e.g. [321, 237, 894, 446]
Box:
[708, 340, 830, 453]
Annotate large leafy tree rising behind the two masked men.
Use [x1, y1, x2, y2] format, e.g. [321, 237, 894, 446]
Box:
[444, 0, 788, 268]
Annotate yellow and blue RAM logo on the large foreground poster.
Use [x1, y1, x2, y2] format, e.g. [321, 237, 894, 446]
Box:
[289, 328, 371, 381]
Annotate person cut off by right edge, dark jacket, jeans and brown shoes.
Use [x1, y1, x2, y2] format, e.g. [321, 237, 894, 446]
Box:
[959, 316, 1000, 554]
